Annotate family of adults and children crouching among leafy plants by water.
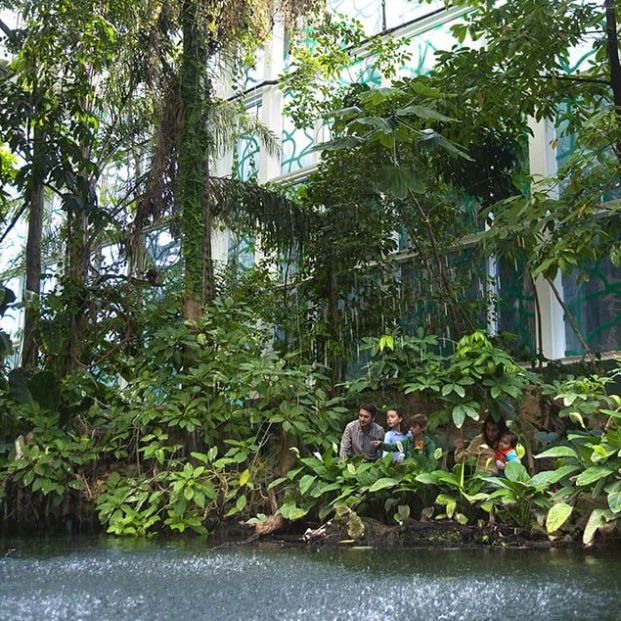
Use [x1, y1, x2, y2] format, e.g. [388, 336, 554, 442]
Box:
[340, 404, 520, 476]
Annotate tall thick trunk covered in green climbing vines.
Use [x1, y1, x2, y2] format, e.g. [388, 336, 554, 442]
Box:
[177, 0, 209, 320]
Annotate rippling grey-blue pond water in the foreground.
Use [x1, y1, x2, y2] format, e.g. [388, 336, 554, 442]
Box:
[0, 538, 621, 621]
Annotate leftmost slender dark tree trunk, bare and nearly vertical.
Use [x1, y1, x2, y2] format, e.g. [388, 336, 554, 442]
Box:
[21, 127, 45, 368]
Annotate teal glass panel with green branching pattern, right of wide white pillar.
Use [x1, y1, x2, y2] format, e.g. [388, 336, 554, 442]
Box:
[563, 259, 621, 356]
